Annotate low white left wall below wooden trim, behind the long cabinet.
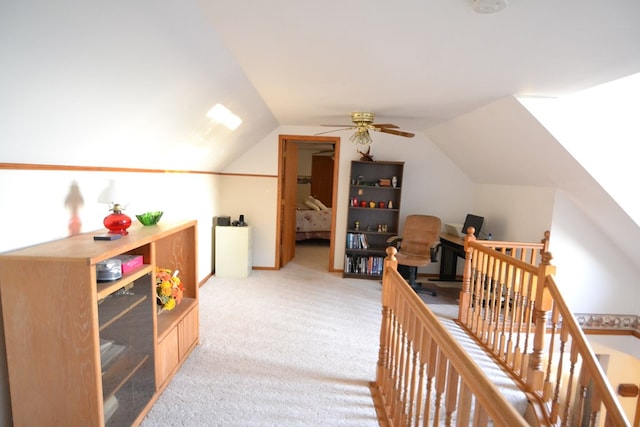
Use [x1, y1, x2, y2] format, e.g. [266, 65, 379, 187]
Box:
[0, 170, 219, 279]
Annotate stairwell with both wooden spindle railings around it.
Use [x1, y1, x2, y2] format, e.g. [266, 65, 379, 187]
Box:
[371, 231, 631, 426]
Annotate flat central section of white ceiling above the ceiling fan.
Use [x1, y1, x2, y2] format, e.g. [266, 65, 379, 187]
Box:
[201, 0, 640, 131]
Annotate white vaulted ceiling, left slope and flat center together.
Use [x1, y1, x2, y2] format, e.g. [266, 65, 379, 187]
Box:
[0, 0, 640, 176]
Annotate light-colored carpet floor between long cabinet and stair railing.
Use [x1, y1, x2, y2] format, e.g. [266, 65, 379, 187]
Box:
[142, 247, 381, 427]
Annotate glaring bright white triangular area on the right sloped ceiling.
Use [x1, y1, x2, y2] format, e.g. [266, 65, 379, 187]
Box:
[518, 73, 640, 225]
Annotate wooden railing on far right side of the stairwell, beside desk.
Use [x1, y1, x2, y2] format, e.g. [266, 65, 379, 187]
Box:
[458, 229, 630, 427]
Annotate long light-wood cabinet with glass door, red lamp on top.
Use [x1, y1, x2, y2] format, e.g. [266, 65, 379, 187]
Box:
[0, 221, 199, 426]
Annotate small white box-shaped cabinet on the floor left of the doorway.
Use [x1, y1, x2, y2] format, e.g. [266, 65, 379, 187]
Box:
[215, 225, 252, 277]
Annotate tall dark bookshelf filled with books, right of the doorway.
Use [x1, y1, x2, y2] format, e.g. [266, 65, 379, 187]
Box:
[343, 161, 404, 279]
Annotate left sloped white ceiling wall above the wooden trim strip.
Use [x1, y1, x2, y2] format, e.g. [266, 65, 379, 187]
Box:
[0, 0, 276, 174]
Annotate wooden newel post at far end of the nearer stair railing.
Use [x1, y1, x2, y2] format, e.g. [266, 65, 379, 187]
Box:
[376, 246, 398, 386]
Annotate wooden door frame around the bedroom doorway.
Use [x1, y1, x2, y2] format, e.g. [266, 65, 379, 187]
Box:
[275, 135, 340, 272]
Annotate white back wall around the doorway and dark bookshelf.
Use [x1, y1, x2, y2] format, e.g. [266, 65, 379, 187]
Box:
[221, 126, 473, 273]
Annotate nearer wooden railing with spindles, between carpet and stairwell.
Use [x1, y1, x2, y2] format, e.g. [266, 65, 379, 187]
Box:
[371, 248, 529, 427]
